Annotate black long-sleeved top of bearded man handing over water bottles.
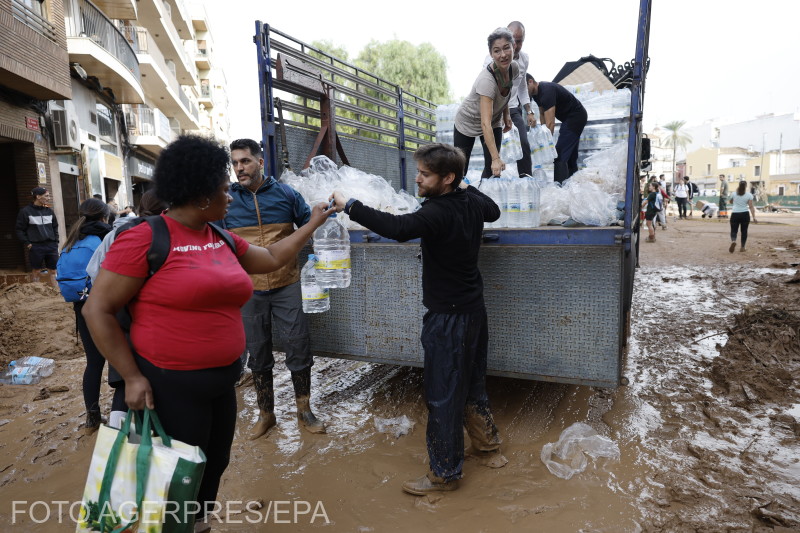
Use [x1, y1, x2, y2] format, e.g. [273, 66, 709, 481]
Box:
[350, 186, 500, 313]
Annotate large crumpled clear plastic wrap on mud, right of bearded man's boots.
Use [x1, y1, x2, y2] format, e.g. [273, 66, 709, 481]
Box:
[541, 422, 619, 479]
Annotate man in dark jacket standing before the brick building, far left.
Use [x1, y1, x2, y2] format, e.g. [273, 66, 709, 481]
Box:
[16, 187, 58, 287]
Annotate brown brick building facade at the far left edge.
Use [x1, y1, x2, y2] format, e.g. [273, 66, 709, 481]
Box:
[0, 0, 72, 269]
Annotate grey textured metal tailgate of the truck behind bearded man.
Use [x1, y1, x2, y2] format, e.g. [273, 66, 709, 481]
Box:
[304, 244, 622, 387]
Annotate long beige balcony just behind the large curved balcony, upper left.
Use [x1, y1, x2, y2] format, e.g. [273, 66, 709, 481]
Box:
[125, 26, 199, 129]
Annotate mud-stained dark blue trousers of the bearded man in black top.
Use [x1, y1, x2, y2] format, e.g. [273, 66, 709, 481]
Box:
[421, 308, 500, 481]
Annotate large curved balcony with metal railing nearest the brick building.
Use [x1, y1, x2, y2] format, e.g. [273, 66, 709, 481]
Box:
[64, 0, 144, 104]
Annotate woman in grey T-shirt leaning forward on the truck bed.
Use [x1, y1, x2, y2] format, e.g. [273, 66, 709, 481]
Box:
[453, 28, 519, 178]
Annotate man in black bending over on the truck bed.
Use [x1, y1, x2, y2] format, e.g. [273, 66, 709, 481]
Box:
[526, 74, 588, 183]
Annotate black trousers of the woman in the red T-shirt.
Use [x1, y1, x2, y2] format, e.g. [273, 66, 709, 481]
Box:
[134, 354, 242, 519]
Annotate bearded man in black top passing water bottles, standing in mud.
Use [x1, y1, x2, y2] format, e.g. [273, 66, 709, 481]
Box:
[333, 144, 506, 495]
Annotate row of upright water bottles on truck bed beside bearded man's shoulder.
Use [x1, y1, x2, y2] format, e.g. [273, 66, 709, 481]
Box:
[479, 177, 542, 228]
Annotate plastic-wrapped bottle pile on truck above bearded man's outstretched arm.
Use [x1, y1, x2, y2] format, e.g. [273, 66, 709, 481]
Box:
[280, 155, 420, 229]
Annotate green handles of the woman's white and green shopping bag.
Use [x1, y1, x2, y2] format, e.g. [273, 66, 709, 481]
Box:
[97, 408, 172, 533]
